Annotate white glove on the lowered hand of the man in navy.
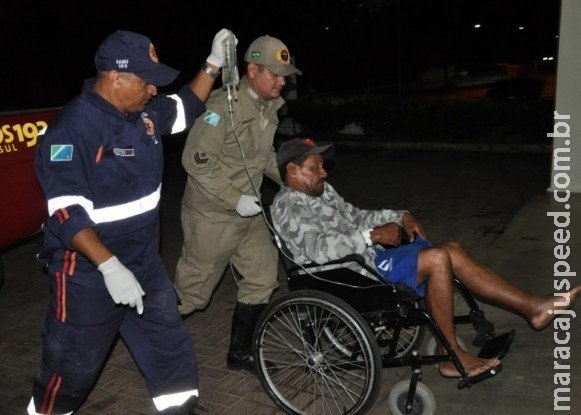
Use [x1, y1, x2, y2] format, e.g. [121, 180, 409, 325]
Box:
[97, 256, 145, 314]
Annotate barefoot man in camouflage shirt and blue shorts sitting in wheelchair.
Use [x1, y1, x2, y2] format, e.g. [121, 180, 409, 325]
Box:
[270, 138, 581, 377]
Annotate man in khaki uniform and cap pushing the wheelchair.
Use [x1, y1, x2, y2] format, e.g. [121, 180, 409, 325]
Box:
[175, 36, 301, 371]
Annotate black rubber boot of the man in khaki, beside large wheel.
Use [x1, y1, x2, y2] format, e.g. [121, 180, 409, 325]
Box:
[226, 303, 266, 373]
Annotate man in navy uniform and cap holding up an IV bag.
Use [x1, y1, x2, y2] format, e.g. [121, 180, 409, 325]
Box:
[28, 29, 229, 415]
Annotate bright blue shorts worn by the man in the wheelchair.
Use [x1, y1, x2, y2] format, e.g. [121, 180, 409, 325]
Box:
[374, 236, 433, 297]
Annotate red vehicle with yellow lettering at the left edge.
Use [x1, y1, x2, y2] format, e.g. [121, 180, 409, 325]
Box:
[0, 108, 59, 284]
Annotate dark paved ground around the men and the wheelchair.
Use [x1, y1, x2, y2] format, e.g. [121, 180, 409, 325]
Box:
[0, 145, 581, 415]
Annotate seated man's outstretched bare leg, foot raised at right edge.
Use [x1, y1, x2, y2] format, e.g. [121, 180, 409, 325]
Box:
[440, 242, 581, 330]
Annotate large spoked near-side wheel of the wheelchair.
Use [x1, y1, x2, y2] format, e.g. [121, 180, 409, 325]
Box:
[254, 290, 382, 415]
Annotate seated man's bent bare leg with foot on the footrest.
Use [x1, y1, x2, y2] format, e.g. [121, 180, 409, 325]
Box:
[418, 247, 500, 377]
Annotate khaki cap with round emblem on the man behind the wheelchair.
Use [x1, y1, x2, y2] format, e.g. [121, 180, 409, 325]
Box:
[244, 35, 302, 76]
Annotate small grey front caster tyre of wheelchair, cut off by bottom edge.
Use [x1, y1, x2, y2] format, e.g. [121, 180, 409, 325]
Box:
[388, 380, 436, 415]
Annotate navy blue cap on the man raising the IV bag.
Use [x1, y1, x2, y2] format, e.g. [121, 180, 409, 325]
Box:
[95, 30, 180, 86]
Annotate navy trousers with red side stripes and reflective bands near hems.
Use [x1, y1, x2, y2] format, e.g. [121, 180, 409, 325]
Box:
[33, 258, 198, 414]
